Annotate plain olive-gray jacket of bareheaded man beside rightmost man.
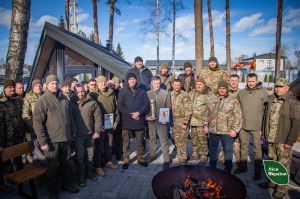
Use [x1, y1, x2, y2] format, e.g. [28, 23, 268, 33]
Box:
[237, 87, 268, 131]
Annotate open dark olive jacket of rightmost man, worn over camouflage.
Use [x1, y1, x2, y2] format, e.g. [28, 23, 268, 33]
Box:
[263, 91, 300, 146]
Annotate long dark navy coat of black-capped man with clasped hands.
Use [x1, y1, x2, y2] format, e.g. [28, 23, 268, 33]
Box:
[118, 86, 149, 130]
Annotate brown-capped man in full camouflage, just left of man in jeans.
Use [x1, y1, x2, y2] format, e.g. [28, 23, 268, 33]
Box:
[189, 78, 212, 163]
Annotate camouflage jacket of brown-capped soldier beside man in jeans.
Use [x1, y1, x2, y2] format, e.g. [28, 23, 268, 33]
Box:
[189, 88, 213, 126]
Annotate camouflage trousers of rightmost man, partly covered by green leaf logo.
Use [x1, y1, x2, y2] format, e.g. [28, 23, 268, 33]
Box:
[268, 143, 293, 193]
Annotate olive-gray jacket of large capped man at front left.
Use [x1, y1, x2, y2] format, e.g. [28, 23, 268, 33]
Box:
[33, 90, 74, 146]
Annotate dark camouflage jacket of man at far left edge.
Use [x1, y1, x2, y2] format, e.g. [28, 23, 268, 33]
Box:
[0, 93, 24, 147]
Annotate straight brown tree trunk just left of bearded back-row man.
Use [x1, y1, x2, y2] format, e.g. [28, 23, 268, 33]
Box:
[194, 0, 204, 77]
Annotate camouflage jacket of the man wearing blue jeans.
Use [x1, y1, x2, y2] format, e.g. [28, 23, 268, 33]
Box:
[207, 95, 242, 134]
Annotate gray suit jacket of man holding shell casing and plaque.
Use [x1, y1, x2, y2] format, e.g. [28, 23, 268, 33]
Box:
[147, 89, 171, 122]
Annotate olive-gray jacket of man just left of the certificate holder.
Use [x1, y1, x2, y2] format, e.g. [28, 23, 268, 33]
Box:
[71, 96, 102, 137]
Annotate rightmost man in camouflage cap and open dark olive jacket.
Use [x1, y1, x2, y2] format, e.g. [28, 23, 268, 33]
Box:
[259, 78, 300, 198]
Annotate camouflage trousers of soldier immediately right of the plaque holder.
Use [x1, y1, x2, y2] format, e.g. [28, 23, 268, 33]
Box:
[173, 122, 188, 162]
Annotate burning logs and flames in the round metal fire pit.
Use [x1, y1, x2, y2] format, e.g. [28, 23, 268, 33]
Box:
[174, 174, 225, 199]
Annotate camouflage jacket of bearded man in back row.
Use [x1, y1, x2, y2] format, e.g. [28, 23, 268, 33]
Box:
[200, 67, 228, 93]
